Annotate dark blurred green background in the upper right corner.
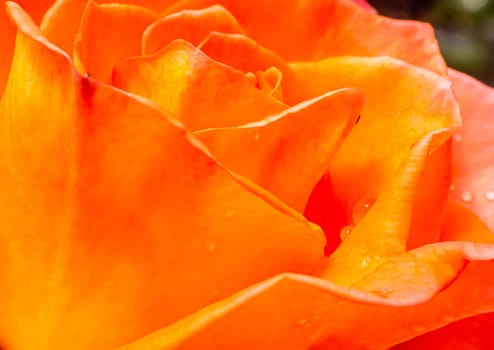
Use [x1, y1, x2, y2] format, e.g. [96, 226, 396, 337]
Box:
[368, 0, 494, 86]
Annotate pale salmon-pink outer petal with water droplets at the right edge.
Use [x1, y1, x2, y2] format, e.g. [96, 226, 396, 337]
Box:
[449, 70, 494, 231]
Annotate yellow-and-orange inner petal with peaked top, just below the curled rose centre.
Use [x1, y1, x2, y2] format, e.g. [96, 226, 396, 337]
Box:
[113, 40, 286, 130]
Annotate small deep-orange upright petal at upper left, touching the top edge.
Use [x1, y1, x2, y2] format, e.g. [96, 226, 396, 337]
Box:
[74, 0, 158, 82]
